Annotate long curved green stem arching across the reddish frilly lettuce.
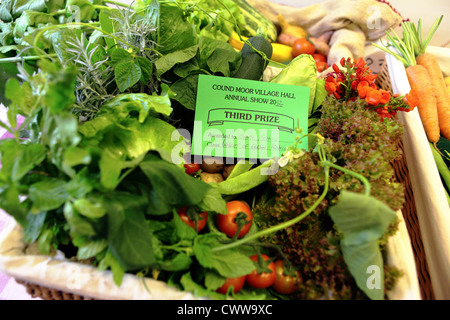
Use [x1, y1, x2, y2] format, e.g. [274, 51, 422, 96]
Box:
[212, 164, 330, 251]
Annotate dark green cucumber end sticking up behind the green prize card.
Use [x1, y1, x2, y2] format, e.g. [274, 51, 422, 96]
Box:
[233, 36, 273, 81]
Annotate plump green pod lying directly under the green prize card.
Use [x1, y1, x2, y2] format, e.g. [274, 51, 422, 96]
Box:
[214, 160, 278, 195]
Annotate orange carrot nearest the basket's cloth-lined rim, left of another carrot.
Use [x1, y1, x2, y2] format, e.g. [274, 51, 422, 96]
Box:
[406, 64, 440, 143]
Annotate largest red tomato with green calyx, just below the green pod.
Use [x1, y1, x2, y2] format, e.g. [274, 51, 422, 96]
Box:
[217, 200, 253, 238]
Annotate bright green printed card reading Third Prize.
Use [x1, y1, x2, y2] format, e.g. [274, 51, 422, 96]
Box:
[191, 75, 310, 160]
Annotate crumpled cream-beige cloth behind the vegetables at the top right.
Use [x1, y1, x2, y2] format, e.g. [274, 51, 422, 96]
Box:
[248, 0, 402, 65]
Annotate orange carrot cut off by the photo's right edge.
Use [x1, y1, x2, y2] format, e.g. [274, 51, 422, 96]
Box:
[416, 53, 450, 139]
